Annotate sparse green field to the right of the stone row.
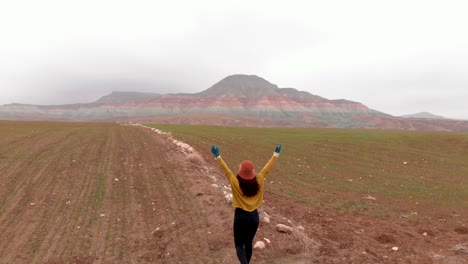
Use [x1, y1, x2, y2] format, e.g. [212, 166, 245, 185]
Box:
[150, 125, 468, 220]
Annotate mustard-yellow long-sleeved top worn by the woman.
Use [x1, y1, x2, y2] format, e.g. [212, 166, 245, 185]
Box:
[216, 153, 279, 212]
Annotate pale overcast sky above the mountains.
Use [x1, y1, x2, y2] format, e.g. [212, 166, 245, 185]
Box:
[0, 0, 468, 119]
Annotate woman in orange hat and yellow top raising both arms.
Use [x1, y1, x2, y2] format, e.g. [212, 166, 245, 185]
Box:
[211, 144, 281, 264]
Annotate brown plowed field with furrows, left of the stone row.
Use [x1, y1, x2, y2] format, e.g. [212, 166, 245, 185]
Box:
[0, 122, 234, 263]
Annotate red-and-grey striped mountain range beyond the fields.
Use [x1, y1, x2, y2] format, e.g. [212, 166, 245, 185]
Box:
[0, 74, 468, 131]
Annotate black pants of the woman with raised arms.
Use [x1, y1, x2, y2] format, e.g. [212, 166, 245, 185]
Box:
[234, 208, 260, 264]
